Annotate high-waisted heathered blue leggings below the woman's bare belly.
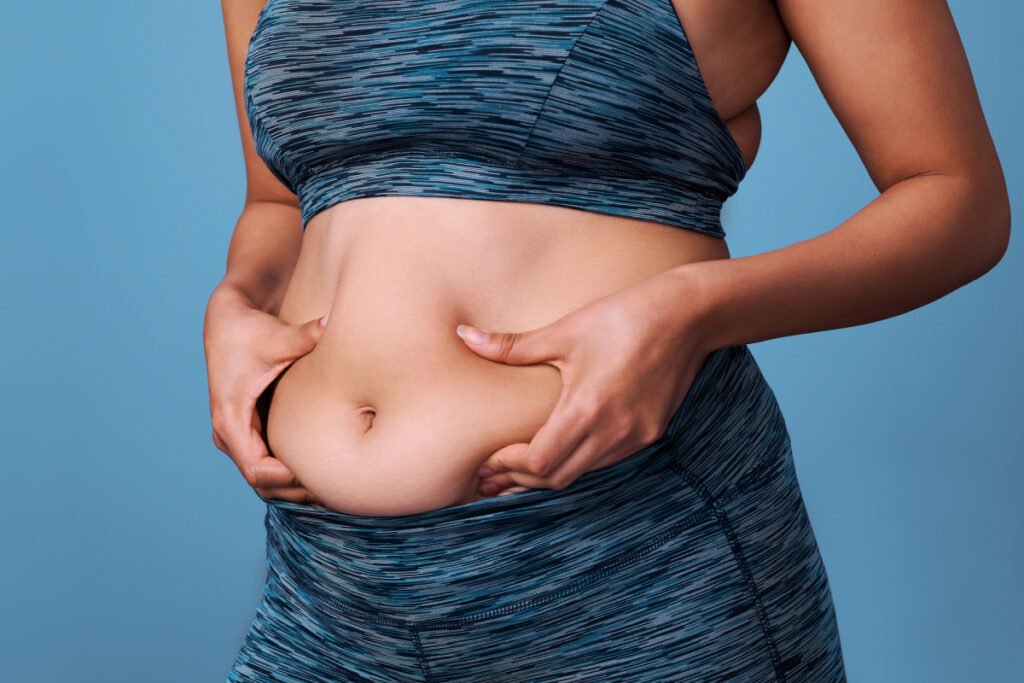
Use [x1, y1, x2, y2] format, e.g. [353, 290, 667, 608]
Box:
[227, 345, 846, 683]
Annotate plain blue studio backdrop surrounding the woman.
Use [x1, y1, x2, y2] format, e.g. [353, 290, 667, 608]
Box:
[0, 0, 1024, 683]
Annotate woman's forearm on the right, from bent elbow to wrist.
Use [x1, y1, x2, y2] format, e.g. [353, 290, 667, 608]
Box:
[670, 174, 1010, 349]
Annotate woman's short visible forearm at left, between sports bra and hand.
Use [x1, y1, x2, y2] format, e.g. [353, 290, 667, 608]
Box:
[217, 197, 302, 315]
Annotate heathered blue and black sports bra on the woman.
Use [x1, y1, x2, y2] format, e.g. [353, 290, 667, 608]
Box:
[244, 0, 745, 237]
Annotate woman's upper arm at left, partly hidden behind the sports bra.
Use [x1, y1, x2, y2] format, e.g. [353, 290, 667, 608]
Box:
[220, 0, 299, 208]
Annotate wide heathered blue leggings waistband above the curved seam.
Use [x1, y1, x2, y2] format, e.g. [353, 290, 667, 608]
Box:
[258, 345, 792, 621]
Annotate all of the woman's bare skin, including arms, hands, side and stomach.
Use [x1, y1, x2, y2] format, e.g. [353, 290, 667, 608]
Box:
[205, 0, 1010, 514]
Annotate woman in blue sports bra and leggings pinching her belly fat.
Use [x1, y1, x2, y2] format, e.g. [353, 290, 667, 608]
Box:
[205, 0, 1010, 681]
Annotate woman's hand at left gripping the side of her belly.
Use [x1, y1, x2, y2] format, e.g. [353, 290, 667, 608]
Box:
[203, 284, 327, 507]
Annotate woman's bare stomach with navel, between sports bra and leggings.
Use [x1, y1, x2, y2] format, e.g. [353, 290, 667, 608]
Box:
[266, 197, 729, 515]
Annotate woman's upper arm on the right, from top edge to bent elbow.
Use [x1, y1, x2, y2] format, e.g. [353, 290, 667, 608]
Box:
[776, 0, 1009, 209]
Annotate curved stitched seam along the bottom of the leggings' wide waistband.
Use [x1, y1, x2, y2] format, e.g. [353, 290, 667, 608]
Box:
[306, 457, 770, 631]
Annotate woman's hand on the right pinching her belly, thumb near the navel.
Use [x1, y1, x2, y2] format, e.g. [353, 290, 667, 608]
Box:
[457, 270, 712, 496]
